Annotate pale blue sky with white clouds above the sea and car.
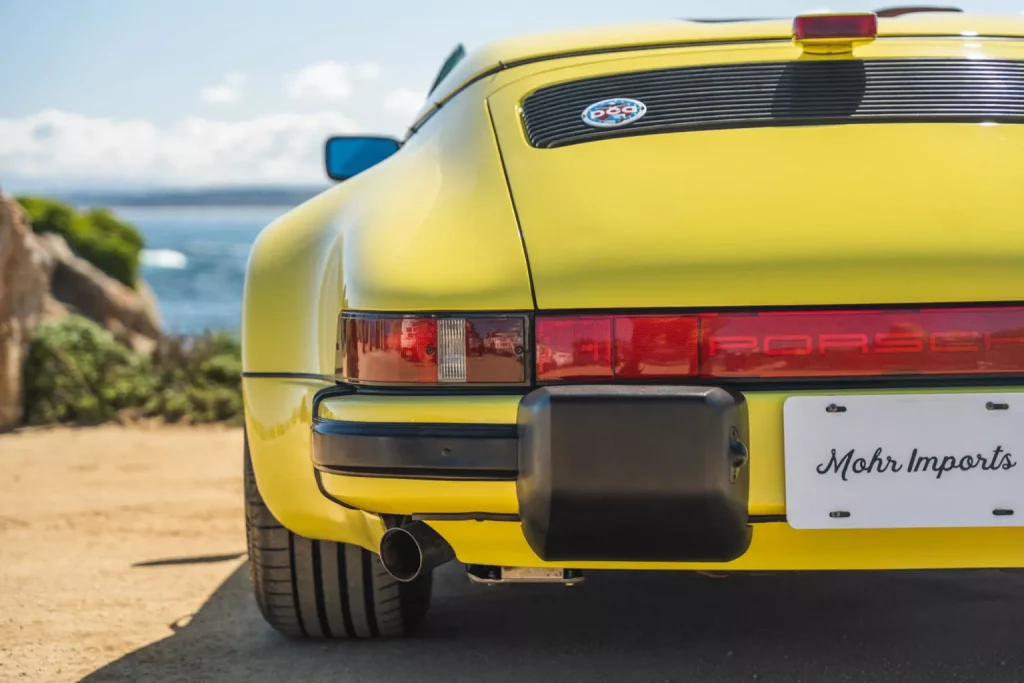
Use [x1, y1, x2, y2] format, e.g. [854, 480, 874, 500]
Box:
[0, 0, 1024, 189]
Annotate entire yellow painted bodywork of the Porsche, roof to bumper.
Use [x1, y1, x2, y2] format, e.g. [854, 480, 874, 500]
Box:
[243, 15, 1024, 569]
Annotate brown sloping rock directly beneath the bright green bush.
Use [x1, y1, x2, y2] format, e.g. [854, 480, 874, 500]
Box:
[37, 233, 161, 353]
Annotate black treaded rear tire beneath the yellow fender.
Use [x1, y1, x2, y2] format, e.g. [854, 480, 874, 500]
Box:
[245, 438, 431, 638]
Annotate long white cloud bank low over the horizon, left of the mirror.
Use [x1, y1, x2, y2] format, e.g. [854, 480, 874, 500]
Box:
[0, 110, 359, 184]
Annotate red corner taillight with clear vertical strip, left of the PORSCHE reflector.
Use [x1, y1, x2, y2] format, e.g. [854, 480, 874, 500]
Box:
[336, 313, 526, 384]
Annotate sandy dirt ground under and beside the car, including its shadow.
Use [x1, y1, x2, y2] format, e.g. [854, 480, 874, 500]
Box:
[6, 427, 1024, 683]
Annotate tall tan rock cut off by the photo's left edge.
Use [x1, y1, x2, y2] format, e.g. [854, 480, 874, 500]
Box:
[0, 195, 49, 430]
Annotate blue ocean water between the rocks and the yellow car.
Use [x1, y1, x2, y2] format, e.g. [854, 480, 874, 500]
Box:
[121, 207, 291, 334]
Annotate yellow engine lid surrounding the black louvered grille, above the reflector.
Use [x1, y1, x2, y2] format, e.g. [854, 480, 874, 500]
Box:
[490, 41, 1024, 309]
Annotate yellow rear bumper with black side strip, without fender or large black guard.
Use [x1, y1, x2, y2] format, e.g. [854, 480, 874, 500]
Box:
[306, 388, 1024, 570]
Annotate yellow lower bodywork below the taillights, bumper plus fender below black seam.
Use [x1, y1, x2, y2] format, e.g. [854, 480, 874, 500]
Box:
[243, 378, 1024, 571]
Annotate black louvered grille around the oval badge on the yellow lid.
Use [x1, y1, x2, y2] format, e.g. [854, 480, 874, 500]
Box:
[522, 59, 1024, 147]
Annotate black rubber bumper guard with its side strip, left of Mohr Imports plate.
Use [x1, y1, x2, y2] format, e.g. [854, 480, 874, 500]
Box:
[312, 386, 757, 561]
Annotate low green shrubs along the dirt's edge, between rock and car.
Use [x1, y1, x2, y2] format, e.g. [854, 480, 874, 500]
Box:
[25, 315, 243, 424]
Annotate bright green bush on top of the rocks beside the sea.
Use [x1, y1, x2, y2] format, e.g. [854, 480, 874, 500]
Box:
[17, 197, 143, 287]
